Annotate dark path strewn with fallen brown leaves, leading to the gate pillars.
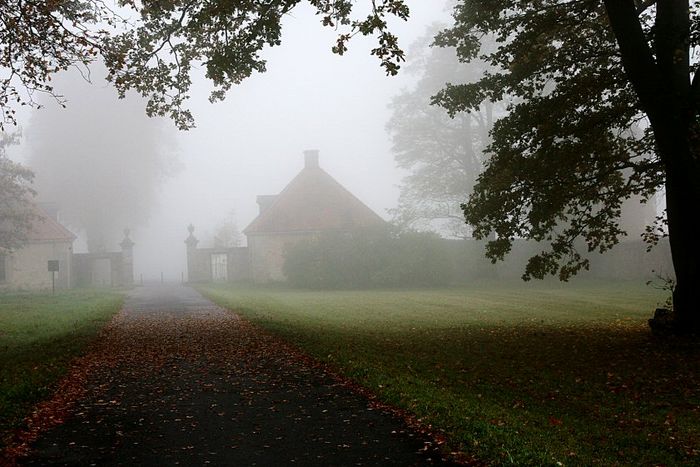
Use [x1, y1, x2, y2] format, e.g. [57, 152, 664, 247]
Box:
[21, 285, 452, 466]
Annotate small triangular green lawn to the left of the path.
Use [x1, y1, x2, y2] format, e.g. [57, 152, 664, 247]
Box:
[0, 290, 123, 448]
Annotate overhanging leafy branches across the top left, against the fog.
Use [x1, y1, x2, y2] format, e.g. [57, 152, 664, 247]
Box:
[0, 0, 408, 129]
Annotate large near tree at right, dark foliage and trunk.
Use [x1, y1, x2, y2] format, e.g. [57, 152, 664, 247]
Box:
[434, 0, 700, 334]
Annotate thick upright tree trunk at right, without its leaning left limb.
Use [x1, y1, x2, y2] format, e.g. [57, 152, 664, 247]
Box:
[650, 0, 700, 335]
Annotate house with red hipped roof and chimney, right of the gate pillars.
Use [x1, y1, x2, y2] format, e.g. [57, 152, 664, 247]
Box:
[243, 150, 386, 282]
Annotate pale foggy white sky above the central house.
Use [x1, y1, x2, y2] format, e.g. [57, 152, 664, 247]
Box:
[8, 0, 449, 280]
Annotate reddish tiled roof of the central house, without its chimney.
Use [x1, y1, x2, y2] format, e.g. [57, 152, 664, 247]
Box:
[243, 165, 385, 235]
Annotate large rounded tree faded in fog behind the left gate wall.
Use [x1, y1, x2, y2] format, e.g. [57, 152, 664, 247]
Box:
[25, 64, 178, 252]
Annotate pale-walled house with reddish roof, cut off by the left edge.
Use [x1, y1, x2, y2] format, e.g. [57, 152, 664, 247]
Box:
[0, 207, 76, 289]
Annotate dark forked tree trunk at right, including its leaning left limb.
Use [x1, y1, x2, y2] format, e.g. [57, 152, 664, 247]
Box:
[603, 0, 700, 336]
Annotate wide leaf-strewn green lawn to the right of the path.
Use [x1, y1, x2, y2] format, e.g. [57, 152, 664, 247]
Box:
[200, 282, 700, 465]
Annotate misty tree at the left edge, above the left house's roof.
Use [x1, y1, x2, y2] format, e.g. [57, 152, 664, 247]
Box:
[0, 132, 35, 255]
